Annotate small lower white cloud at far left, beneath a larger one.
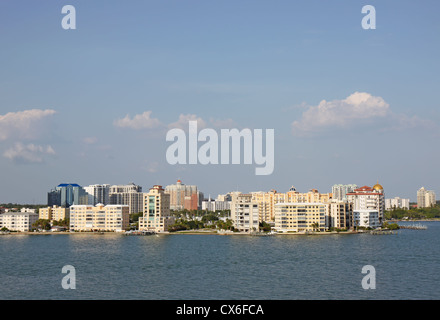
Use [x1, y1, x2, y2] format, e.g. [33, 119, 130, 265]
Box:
[3, 142, 55, 163]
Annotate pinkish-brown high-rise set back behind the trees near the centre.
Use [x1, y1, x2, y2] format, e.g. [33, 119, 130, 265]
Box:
[165, 180, 203, 210]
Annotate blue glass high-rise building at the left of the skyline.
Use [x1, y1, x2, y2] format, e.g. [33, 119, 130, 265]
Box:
[47, 183, 89, 208]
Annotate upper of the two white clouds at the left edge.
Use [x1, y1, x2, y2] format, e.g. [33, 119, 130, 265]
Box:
[0, 109, 56, 141]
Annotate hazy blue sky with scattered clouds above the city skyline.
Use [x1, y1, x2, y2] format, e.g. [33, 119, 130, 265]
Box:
[0, 0, 440, 203]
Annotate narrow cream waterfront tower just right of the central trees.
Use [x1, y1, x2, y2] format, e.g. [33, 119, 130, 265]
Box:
[231, 192, 259, 232]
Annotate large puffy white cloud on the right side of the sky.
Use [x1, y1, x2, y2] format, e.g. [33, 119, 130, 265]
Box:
[292, 92, 390, 135]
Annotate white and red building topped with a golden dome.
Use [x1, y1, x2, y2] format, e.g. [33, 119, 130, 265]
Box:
[347, 183, 385, 227]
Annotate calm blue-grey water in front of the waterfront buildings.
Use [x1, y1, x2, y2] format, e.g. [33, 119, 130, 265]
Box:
[0, 222, 440, 300]
